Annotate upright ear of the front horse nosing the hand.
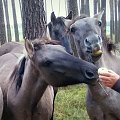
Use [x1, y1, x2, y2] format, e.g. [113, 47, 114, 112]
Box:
[25, 38, 34, 58]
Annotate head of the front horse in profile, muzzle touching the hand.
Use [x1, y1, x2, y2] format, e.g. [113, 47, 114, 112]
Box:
[25, 40, 98, 87]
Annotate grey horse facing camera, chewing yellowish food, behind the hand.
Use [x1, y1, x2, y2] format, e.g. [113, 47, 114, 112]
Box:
[70, 10, 120, 120]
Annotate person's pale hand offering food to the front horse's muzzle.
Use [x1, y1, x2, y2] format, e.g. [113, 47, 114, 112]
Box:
[98, 70, 120, 88]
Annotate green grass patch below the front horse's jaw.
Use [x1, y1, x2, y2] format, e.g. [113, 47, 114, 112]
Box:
[54, 85, 89, 120]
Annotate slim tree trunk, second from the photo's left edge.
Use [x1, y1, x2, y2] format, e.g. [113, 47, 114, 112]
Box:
[3, 0, 12, 42]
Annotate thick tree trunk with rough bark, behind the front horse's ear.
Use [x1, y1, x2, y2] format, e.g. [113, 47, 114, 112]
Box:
[22, 0, 46, 40]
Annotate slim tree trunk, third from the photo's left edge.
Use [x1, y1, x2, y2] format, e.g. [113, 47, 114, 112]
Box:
[11, 0, 19, 42]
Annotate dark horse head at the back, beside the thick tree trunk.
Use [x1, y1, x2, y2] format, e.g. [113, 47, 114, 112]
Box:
[48, 12, 72, 54]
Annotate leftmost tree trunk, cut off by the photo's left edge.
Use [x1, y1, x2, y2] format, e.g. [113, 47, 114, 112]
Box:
[0, 0, 6, 45]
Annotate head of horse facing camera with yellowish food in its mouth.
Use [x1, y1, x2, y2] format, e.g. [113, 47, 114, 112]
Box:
[70, 10, 104, 62]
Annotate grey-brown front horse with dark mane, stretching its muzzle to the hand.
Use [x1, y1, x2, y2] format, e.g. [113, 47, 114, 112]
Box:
[0, 37, 97, 120]
